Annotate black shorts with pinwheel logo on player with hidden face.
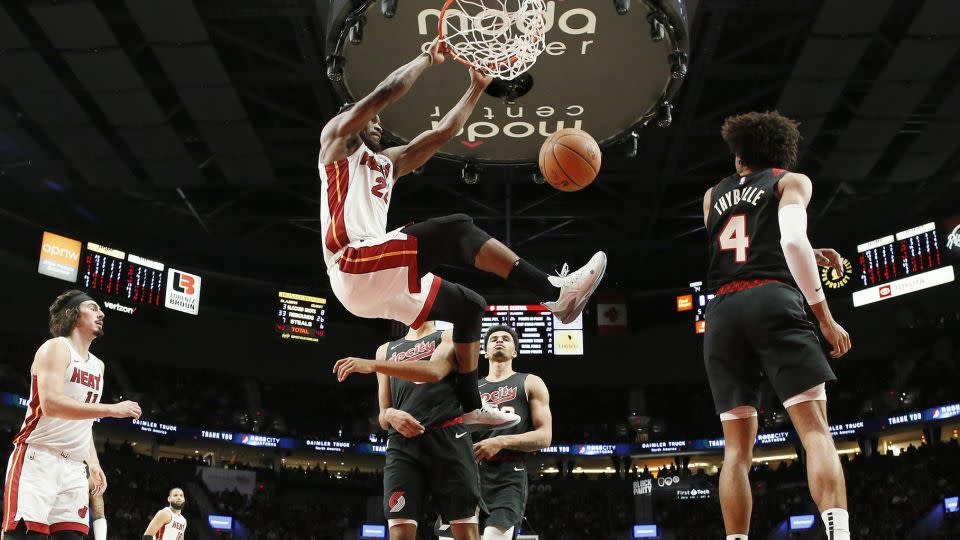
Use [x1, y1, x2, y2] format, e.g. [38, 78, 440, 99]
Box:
[383, 425, 481, 521]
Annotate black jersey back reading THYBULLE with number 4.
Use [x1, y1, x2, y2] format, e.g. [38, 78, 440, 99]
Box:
[707, 169, 793, 290]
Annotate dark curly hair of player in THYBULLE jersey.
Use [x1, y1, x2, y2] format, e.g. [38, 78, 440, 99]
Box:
[720, 111, 800, 169]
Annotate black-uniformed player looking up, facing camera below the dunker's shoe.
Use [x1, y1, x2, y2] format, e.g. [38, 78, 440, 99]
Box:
[437, 325, 553, 540]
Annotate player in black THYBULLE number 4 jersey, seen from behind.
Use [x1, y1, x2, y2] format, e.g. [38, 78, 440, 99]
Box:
[703, 112, 850, 540]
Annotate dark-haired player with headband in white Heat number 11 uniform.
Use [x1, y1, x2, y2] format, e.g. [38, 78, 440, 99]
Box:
[3, 290, 140, 540]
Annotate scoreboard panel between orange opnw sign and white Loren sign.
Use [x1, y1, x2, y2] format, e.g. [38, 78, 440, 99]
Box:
[79, 242, 164, 306]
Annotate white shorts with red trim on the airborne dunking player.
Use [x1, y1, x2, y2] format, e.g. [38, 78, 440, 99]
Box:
[327, 229, 440, 329]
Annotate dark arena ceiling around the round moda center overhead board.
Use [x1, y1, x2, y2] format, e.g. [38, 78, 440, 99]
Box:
[0, 0, 960, 300]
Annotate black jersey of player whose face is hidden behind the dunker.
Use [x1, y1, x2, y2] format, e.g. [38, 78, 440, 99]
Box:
[386, 331, 463, 433]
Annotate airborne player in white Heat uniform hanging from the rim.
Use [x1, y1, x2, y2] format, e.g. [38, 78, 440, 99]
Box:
[319, 40, 606, 430]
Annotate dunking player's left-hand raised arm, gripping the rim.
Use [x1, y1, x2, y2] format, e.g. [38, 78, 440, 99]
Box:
[320, 38, 444, 163]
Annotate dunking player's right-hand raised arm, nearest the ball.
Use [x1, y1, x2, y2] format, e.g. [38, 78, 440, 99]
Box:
[384, 69, 493, 178]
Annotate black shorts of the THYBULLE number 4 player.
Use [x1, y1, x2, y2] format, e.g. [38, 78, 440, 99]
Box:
[703, 282, 837, 414]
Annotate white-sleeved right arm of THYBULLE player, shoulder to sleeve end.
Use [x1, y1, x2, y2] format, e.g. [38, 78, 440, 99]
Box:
[777, 173, 825, 305]
